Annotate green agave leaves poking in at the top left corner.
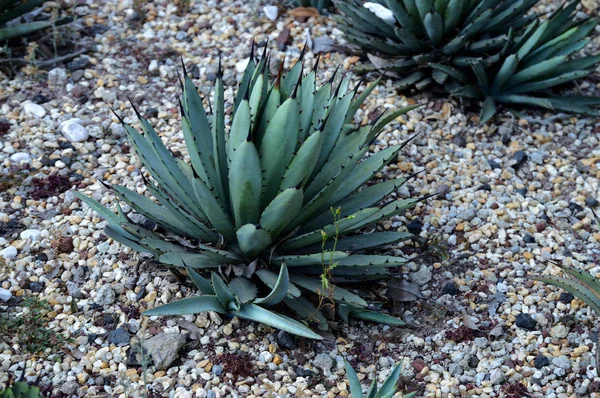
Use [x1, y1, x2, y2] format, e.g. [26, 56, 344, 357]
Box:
[0, 0, 71, 42]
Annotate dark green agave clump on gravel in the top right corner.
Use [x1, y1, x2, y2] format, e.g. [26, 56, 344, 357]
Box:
[336, 0, 600, 123]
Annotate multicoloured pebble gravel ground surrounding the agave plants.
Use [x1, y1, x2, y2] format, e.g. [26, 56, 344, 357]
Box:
[0, 0, 600, 397]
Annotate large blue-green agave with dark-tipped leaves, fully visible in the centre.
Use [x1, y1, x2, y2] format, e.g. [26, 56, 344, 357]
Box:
[77, 46, 421, 339]
